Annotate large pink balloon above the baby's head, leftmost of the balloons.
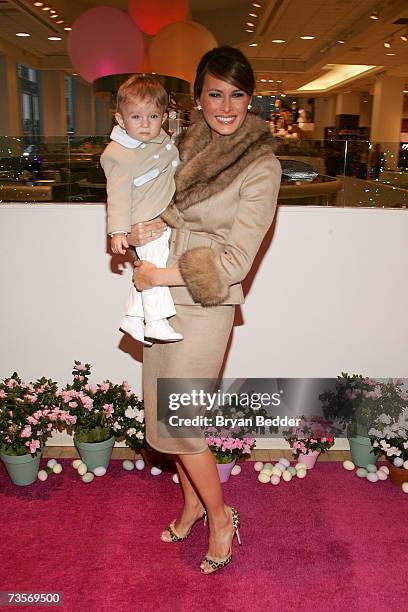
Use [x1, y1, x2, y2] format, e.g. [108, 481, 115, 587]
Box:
[68, 6, 144, 83]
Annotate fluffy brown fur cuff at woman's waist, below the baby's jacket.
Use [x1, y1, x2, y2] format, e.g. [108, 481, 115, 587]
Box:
[178, 247, 229, 306]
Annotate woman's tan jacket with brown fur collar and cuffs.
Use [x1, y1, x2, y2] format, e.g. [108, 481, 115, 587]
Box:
[162, 113, 281, 306]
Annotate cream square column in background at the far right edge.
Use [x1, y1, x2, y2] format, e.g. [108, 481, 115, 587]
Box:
[370, 75, 406, 170]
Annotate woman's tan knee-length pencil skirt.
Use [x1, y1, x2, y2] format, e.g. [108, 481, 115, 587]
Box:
[143, 304, 235, 454]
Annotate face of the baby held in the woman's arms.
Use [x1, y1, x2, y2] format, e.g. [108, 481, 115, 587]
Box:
[115, 98, 167, 142]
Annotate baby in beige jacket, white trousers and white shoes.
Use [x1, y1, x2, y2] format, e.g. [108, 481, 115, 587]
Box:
[101, 75, 183, 346]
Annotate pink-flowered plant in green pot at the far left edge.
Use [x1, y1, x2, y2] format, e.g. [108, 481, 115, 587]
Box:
[0, 372, 73, 485]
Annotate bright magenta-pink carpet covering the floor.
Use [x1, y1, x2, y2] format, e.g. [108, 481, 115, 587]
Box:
[0, 460, 408, 612]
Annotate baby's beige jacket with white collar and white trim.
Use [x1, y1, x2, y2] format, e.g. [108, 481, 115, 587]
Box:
[101, 126, 179, 234]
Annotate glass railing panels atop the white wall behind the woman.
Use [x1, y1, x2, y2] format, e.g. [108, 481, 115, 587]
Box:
[0, 134, 408, 208]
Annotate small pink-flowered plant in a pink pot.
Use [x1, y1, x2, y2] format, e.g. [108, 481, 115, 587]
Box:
[282, 416, 334, 469]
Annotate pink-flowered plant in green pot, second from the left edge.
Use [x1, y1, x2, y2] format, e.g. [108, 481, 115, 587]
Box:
[59, 361, 144, 470]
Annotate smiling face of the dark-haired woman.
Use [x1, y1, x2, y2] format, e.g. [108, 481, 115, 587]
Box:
[197, 73, 251, 136]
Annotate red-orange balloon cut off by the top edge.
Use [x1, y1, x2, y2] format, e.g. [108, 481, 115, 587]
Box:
[128, 0, 189, 36]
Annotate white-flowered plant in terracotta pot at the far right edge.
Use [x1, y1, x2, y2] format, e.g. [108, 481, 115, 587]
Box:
[369, 394, 408, 485]
